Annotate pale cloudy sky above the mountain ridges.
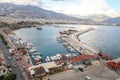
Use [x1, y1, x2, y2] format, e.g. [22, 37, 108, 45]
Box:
[0, 0, 120, 17]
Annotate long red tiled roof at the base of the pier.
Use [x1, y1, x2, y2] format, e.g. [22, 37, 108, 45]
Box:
[71, 55, 98, 62]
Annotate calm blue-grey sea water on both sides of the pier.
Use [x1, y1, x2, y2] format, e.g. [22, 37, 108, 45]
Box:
[14, 25, 120, 58]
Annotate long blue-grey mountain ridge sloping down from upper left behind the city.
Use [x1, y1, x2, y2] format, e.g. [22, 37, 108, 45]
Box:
[0, 3, 77, 20]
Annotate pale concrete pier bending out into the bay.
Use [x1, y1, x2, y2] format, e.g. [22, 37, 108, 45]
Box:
[66, 28, 99, 55]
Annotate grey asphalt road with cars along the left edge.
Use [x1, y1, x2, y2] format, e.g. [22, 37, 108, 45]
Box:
[0, 40, 25, 80]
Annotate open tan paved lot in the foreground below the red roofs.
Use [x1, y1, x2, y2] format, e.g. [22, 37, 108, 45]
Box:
[44, 60, 120, 80]
